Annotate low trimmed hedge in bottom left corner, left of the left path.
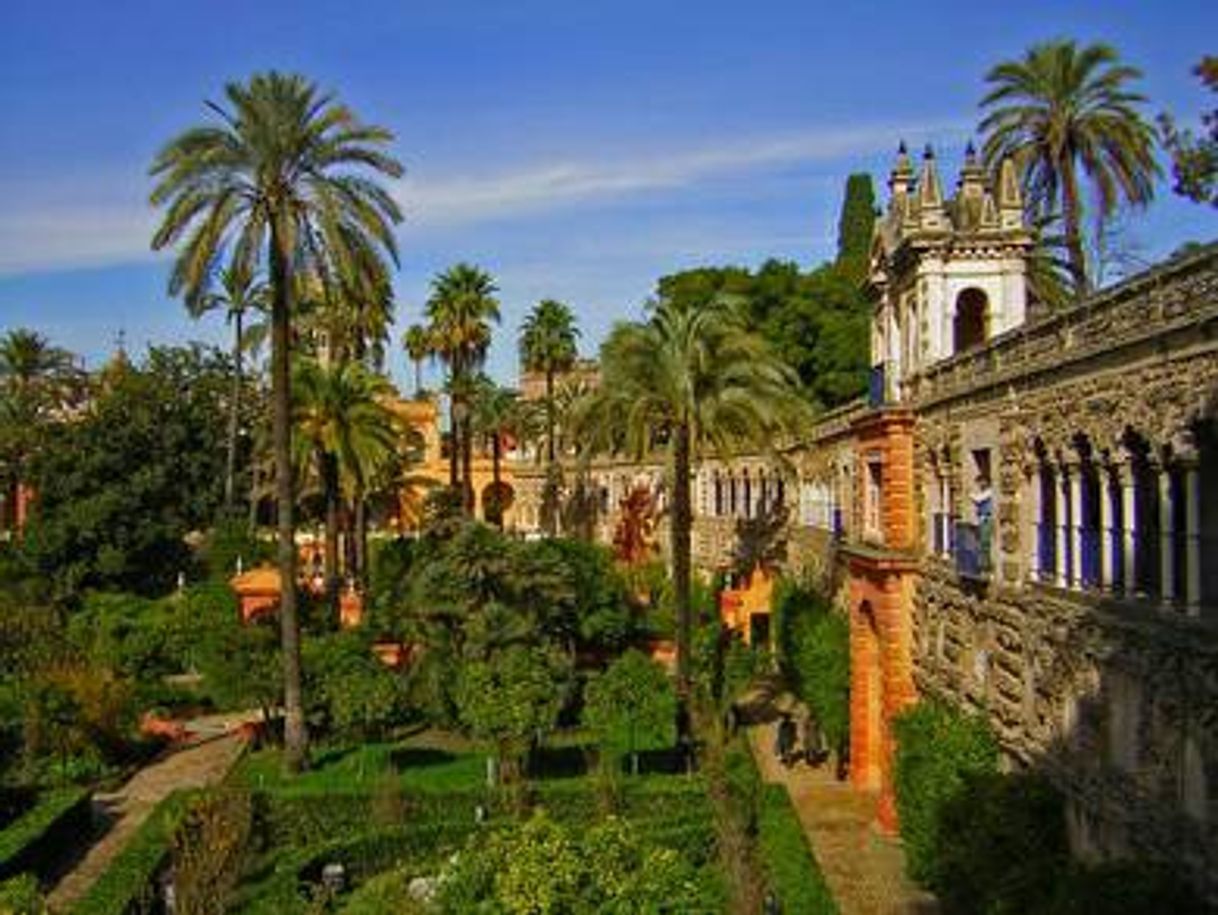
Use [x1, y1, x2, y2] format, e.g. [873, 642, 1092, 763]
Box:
[0, 788, 93, 882]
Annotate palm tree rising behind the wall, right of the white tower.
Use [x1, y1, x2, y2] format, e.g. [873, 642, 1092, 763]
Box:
[980, 40, 1160, 292]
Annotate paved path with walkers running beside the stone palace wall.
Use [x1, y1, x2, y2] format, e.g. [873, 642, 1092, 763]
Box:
[749, 701, 939, 915]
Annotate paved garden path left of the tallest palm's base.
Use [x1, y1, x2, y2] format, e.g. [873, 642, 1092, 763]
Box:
[48, 715, 250, 913]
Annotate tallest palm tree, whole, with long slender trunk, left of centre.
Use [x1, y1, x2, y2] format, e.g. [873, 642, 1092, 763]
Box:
[150, 72, 402, 771]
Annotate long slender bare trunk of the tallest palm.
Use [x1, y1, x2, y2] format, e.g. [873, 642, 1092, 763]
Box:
[270, 219, 308, 772]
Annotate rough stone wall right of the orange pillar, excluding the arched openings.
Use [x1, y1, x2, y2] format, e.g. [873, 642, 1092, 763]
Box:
[911, 247, 1218, 898]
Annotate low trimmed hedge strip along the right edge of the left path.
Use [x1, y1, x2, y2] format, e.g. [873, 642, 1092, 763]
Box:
[71, 792, 194, 915]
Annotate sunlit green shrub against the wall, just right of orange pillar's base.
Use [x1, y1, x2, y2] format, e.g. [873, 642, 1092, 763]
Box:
[893, 701, 998, 885]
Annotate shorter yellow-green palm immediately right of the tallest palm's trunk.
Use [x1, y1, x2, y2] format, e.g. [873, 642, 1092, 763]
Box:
[292, 358, 400, 602]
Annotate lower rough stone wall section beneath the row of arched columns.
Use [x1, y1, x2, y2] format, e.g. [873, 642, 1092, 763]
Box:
[914, 560, 1218, 896]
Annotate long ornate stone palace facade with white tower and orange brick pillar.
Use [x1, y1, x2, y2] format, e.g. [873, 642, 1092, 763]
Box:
[513, 149, 1218, 898]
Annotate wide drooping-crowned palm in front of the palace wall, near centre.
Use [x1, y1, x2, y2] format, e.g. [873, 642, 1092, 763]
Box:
[575, 299, 806, 696]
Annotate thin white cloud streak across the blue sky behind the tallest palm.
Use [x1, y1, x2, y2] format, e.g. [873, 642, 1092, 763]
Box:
[0, 123, 962, 275]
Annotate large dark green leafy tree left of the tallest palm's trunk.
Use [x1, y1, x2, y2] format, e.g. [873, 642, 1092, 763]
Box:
[26, 345, 231, 598]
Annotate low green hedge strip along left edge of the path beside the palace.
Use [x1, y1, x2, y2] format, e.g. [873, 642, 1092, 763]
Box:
[758, 785, 838, 915]
